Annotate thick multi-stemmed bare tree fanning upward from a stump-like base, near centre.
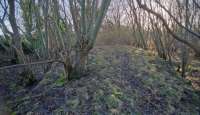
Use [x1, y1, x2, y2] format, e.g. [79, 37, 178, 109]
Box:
[69, 0, 111, 77]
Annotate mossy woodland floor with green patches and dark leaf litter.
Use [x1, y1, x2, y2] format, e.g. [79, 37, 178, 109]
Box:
[0, 46, 200, 115]
